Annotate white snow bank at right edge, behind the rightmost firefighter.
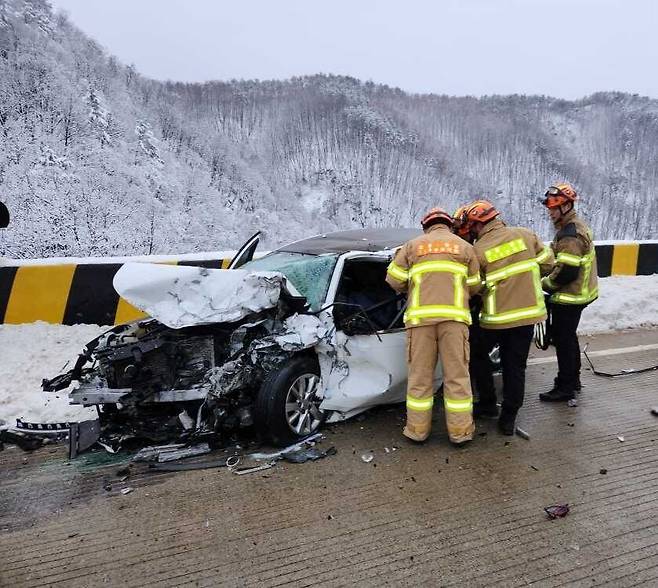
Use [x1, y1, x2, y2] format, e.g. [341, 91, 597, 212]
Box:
[578, 275, 658, 334]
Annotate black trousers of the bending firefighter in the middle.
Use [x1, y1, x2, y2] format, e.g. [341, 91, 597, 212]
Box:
[471, 325, 534, 416]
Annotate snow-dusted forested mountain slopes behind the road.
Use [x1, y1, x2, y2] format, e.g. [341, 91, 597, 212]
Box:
[0, 0, 658, 257]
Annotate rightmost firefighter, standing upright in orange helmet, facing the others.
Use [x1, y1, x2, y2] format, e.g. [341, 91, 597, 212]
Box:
[539, 184, 598, 402]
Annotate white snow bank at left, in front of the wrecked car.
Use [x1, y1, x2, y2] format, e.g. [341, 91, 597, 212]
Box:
[0, 322, 102, 425]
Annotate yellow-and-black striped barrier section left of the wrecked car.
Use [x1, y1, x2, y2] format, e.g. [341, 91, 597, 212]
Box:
[0, 259, 230, 325]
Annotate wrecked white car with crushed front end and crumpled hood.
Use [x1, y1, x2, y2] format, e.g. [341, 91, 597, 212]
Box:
[44, 229, 448, 445]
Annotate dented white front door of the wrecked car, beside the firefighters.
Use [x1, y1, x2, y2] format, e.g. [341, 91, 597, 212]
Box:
[322, 252, 441, 417]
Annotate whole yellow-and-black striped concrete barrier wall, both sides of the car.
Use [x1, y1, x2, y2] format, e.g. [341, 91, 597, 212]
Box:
[0, 241, 658, 325]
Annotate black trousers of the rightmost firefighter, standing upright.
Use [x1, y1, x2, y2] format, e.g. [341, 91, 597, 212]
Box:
[550, 304, 585, 392]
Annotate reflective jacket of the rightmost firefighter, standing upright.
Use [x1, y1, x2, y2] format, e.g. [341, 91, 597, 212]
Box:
[542, 210, 599, 305]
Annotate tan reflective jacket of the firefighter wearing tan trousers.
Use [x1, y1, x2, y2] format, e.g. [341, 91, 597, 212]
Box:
[386, 224, 481, 327]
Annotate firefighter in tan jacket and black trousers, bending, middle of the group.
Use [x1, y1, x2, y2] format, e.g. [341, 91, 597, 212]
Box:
[459, 200, 554, 435]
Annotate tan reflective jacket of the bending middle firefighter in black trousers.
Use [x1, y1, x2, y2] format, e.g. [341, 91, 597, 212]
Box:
[475, 218, 554, 329]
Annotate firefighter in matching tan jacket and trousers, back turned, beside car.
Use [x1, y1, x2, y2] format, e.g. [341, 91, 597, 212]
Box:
[386, 208, 480, 446]
